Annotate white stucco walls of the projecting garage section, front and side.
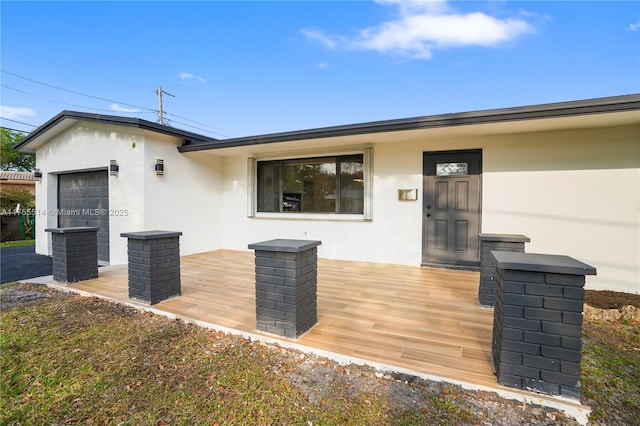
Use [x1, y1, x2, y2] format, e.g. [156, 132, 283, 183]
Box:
[36, 123, 221, 265]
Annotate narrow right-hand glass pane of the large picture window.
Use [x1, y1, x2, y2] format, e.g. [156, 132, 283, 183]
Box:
[340, 155, 364, 214]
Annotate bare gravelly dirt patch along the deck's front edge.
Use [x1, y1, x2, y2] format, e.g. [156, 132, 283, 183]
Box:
[289, 355, 578, 426]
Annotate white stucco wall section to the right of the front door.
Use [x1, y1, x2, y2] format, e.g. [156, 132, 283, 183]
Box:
[483, 127, 640, 293]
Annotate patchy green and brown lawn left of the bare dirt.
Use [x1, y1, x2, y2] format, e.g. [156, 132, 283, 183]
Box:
[0, 295, 480, 425]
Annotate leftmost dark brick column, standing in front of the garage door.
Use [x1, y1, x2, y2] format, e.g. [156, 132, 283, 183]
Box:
[45, 227, 98, 283]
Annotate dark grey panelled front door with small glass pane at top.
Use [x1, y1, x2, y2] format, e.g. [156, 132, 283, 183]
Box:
[422, 150, 482, 267]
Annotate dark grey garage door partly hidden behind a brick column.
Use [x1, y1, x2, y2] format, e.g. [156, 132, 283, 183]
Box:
[58, 170, 109, 262]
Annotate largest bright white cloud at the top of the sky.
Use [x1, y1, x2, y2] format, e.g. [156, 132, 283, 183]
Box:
[302, 0, 534, 59]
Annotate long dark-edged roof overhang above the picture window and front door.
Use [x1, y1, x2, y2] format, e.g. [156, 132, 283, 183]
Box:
[178, 94, 640, 155]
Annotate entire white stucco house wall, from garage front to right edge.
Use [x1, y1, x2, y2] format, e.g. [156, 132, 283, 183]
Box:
[36, 119, 640, 293]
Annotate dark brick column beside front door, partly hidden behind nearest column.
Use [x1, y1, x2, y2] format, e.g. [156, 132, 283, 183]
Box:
[478, 234, 531, 306]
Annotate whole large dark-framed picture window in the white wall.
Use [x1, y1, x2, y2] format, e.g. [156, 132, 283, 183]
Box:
[257, 154, 364, 214]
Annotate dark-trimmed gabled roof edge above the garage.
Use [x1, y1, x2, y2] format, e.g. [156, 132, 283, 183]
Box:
[15, 111, 215, 152]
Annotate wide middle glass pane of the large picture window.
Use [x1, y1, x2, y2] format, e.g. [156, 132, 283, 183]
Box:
[282, 157, 336, 213]
